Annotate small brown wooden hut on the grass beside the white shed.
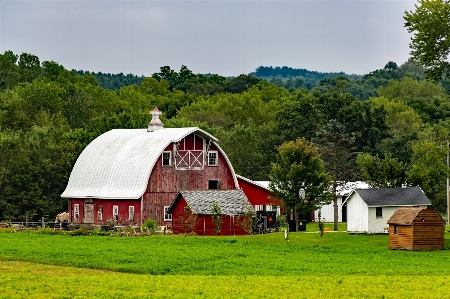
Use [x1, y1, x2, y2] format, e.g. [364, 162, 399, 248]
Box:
[387, 207, 445, 250]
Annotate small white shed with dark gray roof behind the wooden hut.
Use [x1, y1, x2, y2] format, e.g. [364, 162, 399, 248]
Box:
[344, 187, 431, 234]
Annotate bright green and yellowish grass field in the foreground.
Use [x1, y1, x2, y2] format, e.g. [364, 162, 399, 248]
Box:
[0, 226, 450, 298]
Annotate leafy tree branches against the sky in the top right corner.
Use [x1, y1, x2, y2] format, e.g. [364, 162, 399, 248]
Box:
[403, 0, 450, 82]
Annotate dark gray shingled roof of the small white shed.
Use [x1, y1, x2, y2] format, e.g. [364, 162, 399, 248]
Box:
[355, 187, 431, 207]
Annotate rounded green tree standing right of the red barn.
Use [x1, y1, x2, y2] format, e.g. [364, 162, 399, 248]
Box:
[269, 138, 330, 231]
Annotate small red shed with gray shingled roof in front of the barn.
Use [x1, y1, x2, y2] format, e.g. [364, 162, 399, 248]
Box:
[169, 190, 253, 236]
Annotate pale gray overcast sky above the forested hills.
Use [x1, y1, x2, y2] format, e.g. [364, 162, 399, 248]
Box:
[0, 0, 416, 76]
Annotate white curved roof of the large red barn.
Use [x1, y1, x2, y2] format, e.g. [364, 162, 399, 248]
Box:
[61, 128, 238, 199]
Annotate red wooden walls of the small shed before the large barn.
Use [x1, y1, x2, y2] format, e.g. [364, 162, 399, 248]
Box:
[172, 198, 248, 236]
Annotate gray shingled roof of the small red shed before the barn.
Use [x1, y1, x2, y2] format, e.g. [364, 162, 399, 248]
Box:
[169, 189, 253, 215]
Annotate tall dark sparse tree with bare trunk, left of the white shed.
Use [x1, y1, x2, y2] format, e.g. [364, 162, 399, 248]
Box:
[313, 119, 358, 231]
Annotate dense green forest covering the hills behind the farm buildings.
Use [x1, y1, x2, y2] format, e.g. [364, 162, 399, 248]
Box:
[0, 51, 450, 221]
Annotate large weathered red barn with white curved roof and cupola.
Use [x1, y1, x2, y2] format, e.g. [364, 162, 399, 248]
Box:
[61, 108, 250, 226]
